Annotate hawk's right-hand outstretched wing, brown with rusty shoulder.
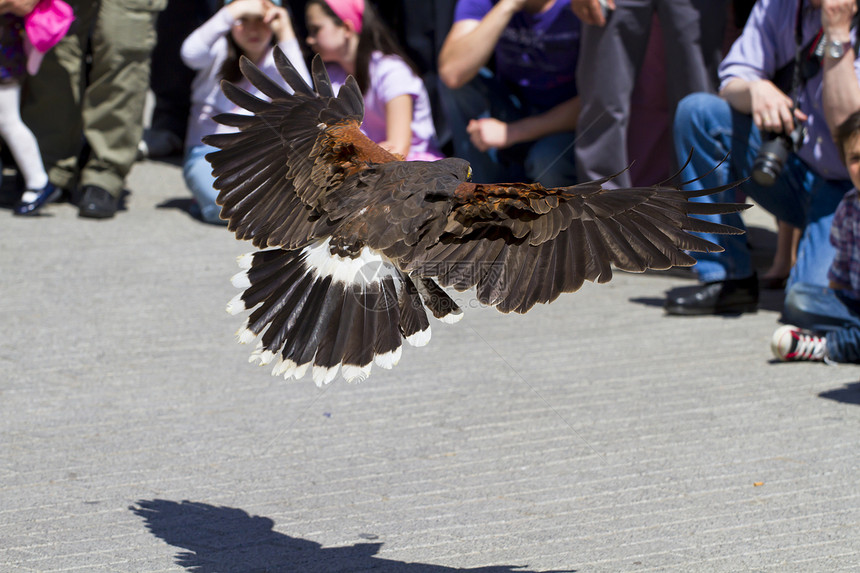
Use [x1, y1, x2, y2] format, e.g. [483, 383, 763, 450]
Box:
[402, 179, 749, 313]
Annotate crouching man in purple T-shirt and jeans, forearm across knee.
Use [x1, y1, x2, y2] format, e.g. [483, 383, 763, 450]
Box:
[439, 0, 580, 187]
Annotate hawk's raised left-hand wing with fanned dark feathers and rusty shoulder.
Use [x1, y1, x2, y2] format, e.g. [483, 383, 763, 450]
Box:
[204, 49, 396, 249]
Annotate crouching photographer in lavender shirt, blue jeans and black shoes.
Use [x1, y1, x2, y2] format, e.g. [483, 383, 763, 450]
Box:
[665, 0, 860, 315]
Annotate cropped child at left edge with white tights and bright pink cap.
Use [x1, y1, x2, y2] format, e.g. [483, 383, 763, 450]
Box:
[0, 0, 71, 215]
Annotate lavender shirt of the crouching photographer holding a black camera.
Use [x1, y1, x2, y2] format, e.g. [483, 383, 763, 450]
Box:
[719, 0, 860, 179]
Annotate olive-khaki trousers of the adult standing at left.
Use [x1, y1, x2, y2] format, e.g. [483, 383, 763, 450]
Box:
[21, 0, 167, 196]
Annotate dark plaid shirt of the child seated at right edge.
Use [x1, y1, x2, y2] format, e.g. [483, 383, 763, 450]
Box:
[827, 189, 860, 298]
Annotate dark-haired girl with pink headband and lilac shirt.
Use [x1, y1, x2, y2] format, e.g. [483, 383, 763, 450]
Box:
[305, 0, 443, 161]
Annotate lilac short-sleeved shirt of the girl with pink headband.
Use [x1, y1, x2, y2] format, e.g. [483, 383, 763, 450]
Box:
[326, 52, 443, 159]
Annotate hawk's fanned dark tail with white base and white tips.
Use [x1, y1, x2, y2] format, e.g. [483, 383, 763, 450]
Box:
[227, 241, 428, 385]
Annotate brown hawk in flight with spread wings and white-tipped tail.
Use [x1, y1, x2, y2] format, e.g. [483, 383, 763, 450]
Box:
[204, 49, 746, 385]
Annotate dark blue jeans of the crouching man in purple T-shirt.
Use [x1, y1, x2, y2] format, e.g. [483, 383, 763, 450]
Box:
[439, 68, 576, 187]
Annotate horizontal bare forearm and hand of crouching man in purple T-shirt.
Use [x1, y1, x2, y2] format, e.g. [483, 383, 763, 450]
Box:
[466, 97, 580, 151]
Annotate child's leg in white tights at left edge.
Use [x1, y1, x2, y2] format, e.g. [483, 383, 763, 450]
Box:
[0, 84, 48, 190]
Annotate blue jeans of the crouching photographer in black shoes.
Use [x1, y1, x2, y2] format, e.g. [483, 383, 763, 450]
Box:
[674, 93, 852, 287]
